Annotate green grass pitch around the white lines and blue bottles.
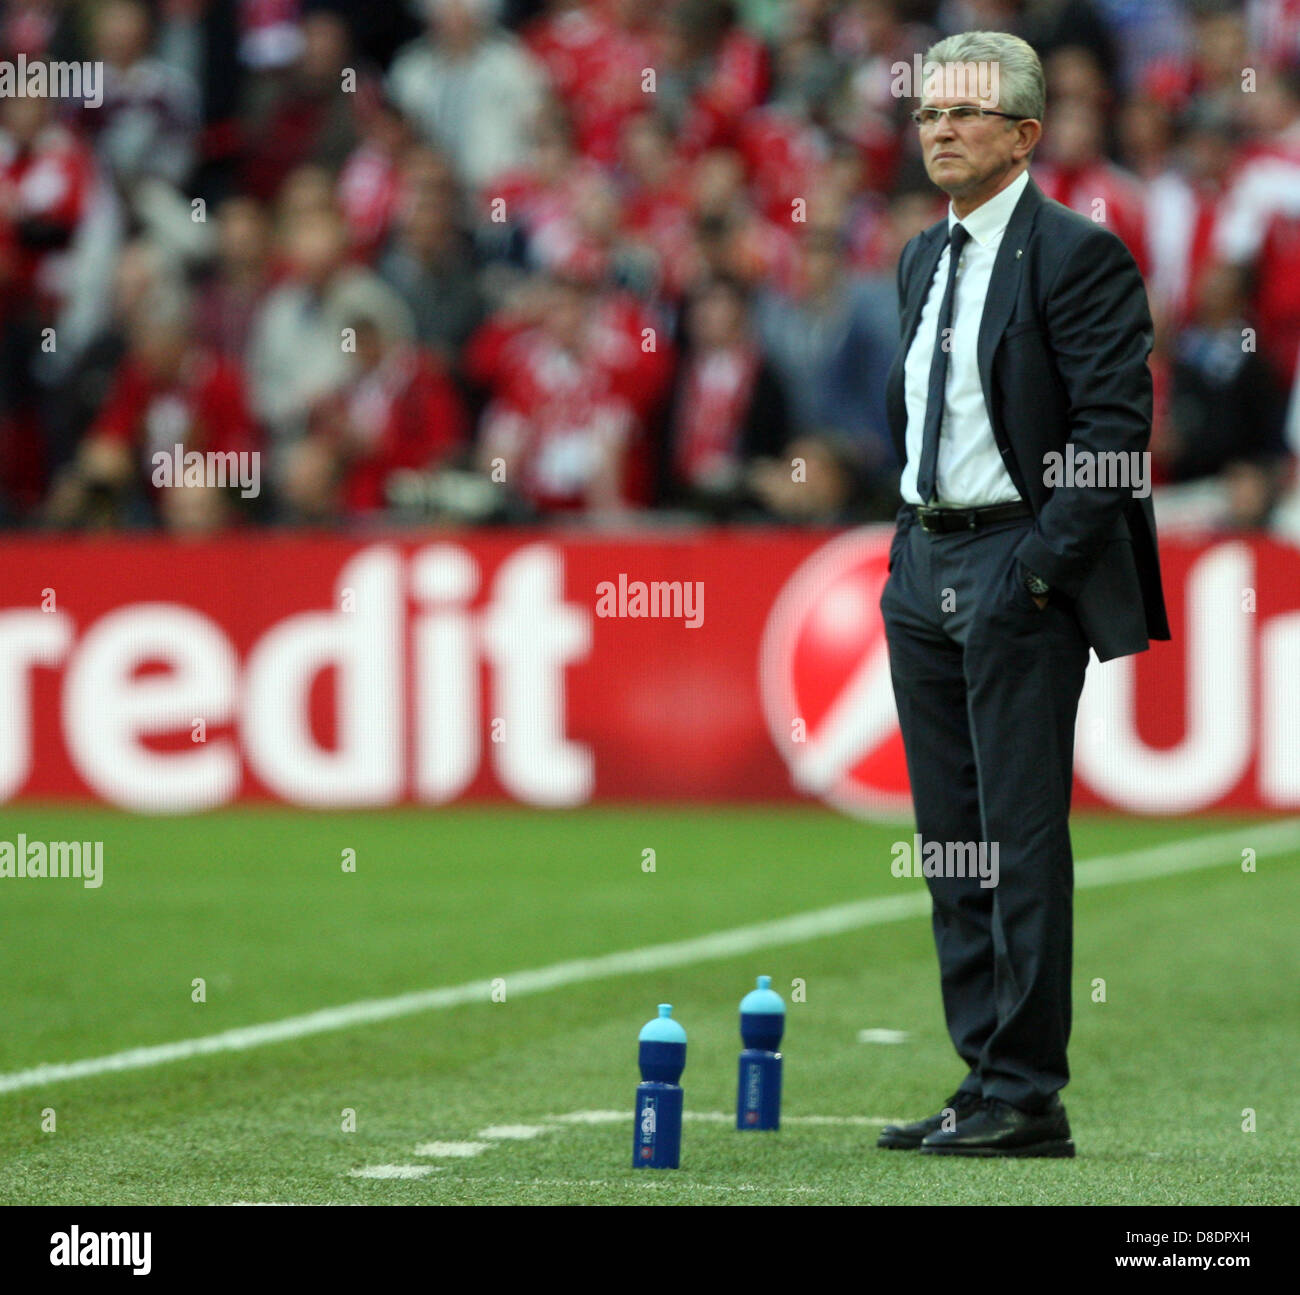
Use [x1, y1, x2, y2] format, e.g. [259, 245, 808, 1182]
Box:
[0, 806, 1300, 1205]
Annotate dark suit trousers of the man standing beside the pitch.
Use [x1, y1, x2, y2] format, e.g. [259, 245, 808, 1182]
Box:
[880, 519, 1088, 1112]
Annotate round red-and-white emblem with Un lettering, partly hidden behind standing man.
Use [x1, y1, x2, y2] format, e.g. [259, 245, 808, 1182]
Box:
[759, 528, 1300, 817]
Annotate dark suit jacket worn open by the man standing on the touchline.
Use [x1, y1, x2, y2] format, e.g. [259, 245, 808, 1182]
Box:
[885, 177, 1170, 661]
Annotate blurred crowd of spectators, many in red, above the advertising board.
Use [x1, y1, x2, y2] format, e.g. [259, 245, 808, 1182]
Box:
[0, 0, 1300, 532]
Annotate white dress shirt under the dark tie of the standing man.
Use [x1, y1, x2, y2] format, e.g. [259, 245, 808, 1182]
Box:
[900, 170, 1030, 508]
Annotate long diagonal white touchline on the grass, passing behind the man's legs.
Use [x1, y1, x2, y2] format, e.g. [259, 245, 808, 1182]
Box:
[0, 818, 1300, 1093]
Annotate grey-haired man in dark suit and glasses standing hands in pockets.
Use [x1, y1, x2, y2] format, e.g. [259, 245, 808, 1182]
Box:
[879, 31, 1169, 1156]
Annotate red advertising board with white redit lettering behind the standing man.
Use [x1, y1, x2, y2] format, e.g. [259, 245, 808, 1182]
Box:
[0, 527, 1300, 815]
